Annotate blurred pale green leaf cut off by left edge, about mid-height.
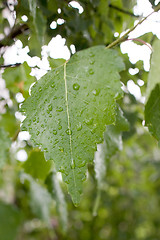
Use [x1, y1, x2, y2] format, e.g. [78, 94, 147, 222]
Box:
[0, 128, 11, 169]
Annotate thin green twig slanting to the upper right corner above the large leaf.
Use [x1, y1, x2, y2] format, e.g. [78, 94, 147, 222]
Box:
[106, 4, 160, 49]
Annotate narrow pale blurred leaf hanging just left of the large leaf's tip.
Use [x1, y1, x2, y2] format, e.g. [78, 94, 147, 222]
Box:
[46, 171, 68, 232]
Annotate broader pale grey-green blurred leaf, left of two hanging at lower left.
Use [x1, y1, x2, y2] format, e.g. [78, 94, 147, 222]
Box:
[21, 173, 51, 224]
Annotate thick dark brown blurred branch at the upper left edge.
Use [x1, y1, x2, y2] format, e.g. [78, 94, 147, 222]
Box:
[0, 24, 29, 48]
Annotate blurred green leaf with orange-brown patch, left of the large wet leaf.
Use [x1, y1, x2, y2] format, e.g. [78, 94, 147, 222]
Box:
[2, 62, 35, 98]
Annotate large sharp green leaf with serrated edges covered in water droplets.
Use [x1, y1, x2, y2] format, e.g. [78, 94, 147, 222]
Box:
[21, 46, 124, 205]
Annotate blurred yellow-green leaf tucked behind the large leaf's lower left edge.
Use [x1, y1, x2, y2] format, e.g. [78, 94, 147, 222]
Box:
[23, 150, 52, 180]
